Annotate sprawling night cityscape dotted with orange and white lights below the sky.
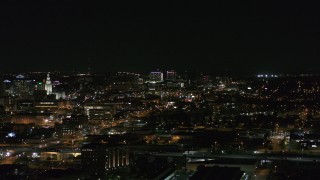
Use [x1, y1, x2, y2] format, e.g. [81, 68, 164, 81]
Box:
[0, 70, 320, 180]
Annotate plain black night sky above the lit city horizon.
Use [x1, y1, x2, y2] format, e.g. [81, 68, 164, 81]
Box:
[0, 0, 320, 73]
